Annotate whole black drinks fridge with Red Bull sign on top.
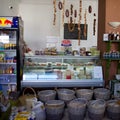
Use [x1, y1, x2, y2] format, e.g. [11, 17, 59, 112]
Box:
[0, 16, 23, 96]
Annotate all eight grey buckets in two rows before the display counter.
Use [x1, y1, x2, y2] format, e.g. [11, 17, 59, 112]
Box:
[38, 88, 120, 120]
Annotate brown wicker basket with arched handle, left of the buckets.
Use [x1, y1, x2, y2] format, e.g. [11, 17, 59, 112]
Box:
[19, 87, 37, 105]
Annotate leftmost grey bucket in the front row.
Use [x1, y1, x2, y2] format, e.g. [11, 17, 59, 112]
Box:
[45, 100, 65, 120]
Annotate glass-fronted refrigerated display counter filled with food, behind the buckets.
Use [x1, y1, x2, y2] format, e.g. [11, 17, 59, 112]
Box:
[21, 55, 104, 87]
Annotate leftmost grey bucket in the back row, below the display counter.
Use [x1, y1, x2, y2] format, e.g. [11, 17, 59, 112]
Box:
[38, 90, 56, 102]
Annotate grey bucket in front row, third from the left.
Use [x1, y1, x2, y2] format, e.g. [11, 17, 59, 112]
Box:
[87, 99, 106, 120]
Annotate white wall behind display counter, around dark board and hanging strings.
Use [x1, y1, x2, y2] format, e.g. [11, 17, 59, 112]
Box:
[19, 0, 98, 51]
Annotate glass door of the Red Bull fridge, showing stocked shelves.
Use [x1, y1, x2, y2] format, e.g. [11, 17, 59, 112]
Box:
[0, 29, 17, 95]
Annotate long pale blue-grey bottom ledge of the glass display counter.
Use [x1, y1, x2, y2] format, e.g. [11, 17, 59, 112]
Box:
[21, 79, 104, 87]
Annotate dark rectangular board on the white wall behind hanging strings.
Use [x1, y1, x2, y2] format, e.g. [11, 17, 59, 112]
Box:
[64, 23, 88, 40]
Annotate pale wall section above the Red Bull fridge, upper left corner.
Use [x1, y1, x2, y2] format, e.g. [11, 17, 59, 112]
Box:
[0, 0, 20, 16]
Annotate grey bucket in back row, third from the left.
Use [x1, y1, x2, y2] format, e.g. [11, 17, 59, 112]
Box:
[76, 89, 93, 100]
